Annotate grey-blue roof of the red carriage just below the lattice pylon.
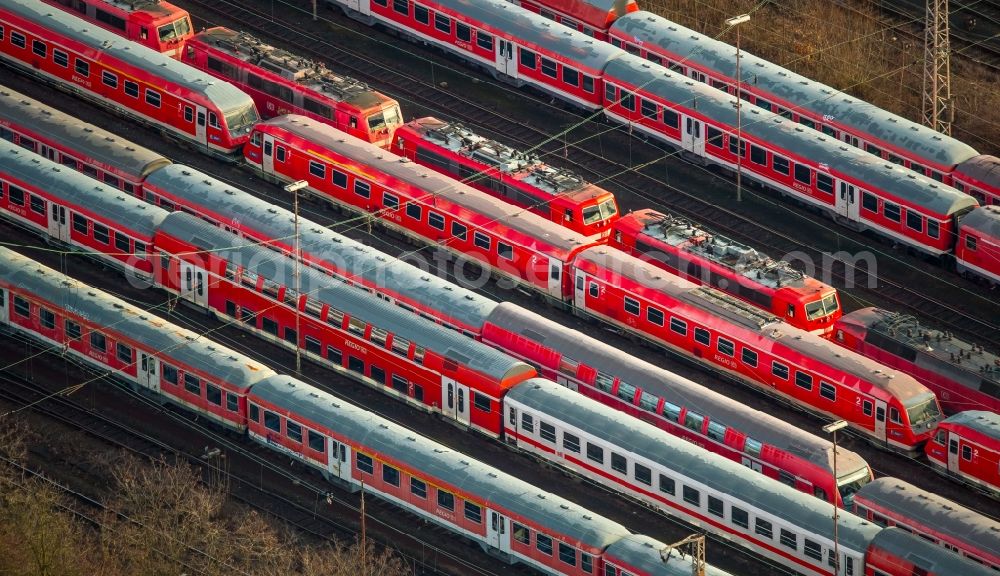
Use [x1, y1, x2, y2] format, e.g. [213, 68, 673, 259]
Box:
[612, 12, 978, 166]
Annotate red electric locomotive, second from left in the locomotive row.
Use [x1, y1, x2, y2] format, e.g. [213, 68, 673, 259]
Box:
[182, 28, 403, 148]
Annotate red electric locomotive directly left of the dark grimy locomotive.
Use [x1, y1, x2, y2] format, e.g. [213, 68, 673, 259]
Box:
[610, 209, 842, 332]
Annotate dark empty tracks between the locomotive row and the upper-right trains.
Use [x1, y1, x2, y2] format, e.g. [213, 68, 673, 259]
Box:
[180, 0, 1000, 349]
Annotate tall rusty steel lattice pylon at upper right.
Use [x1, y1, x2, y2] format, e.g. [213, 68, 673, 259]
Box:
[923, 0, 954, 135]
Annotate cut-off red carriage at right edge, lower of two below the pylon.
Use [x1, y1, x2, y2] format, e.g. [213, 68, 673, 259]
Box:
[955, 205, 1000, 286]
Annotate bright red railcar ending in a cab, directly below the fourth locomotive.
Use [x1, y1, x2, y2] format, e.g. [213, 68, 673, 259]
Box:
[573, 247, 940, 452]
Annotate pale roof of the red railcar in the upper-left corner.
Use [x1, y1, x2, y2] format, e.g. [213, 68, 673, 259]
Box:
[4, 0, 253, 114]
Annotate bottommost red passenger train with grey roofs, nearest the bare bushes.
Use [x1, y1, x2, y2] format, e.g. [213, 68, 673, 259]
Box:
[0, 247, 728, 576]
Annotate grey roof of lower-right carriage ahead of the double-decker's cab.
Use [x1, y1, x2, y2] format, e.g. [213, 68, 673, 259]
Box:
[856, 477, 1000, 557]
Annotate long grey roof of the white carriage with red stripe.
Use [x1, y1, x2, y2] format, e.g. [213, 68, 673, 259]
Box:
[507, 378, 881, 552]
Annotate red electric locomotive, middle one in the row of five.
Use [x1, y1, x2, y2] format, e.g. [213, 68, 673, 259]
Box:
[391, 117, 618, 239]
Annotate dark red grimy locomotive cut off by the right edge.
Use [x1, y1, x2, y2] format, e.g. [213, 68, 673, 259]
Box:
[833, 308, 1000, 414]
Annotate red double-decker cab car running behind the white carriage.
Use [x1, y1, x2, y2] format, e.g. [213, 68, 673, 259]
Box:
[482, 302, 872, 505]
